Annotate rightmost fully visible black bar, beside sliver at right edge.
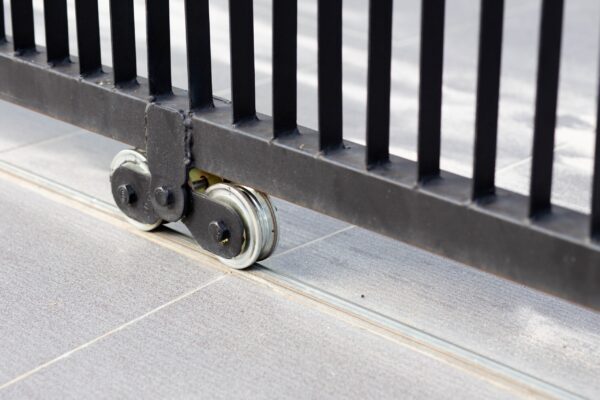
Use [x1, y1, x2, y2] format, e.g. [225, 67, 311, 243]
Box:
[529, 0, 564, 216]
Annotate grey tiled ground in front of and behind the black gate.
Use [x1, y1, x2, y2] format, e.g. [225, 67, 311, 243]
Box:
[0, 0, 600, 399]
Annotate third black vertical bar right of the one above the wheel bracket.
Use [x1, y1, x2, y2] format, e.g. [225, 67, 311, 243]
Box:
[273, 0, 298, 137]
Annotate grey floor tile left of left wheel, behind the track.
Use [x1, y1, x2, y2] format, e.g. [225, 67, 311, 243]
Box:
[0, 131, 129, 203]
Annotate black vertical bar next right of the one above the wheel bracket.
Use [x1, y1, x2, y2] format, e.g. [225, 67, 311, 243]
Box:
[185, 0, 213, 109]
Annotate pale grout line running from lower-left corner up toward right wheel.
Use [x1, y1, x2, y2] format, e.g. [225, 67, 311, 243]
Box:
[0, 274, 228, 390]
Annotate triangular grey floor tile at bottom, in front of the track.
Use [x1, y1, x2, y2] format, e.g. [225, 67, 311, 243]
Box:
[0, 277, 510, 399]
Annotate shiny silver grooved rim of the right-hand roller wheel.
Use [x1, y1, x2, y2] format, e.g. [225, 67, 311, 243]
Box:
[206, 183, 278, 269]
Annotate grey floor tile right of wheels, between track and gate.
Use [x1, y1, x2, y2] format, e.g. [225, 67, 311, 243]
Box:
[261, 229, 600, 398]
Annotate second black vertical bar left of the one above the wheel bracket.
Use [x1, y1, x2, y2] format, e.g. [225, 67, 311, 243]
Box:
[75, 0, 102, 75]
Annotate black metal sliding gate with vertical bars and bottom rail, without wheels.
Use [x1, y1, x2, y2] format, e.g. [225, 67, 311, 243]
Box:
[0, 0, 600, 309]
